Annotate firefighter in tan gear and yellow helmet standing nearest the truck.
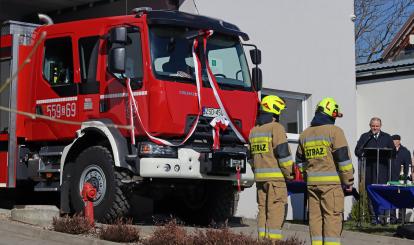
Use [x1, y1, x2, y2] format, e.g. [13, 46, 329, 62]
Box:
[249, 95, 293, 240]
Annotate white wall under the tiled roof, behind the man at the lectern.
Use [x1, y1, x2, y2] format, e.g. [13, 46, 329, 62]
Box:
[357, 75, 414, 222]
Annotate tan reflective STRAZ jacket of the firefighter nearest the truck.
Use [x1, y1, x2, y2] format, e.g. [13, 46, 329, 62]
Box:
[249, 119, 293, 185]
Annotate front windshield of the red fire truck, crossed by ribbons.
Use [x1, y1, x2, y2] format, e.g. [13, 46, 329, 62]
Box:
[150, 26, 252, 90]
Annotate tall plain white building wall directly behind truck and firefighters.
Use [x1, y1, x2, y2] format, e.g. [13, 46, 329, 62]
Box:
[180, 0, 357, 220]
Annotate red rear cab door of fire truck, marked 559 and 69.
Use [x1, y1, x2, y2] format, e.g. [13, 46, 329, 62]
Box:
[32, 34, 80, 140]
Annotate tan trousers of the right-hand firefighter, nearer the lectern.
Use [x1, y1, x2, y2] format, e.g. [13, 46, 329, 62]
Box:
[308, 185, 344, 245]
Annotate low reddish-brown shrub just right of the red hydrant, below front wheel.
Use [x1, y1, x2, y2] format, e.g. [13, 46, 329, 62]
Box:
[99, 218, 140, 242]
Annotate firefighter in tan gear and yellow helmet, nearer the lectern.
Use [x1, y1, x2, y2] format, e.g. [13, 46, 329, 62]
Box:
[296, 98, 354, 245]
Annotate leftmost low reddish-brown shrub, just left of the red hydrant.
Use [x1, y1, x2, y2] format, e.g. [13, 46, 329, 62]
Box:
[52, 214, 93, 234]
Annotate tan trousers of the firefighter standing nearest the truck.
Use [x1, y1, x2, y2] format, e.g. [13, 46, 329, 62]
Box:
[256, 181, 287, 240]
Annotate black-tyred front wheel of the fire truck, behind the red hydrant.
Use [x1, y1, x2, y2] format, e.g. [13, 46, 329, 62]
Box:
[70, 146, 129, 223]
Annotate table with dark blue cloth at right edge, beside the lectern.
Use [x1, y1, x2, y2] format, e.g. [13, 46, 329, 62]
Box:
[367, 184, 414, 214]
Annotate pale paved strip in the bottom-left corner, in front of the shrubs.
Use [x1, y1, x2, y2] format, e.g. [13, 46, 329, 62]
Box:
[0, 220, 119, 245]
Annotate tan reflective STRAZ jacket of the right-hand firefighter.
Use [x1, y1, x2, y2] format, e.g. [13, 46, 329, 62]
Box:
[296, 124, 354, 185]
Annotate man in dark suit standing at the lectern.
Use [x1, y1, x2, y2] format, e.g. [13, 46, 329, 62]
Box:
[355, 117, 395, 224]
